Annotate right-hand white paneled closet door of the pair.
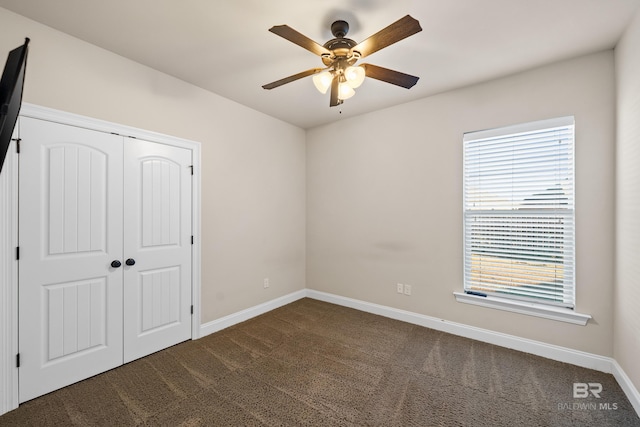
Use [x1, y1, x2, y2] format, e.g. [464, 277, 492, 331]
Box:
[123, 139, 192, 362]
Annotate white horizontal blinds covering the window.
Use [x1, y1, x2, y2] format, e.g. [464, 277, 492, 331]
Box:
[464, 117, 575, 307]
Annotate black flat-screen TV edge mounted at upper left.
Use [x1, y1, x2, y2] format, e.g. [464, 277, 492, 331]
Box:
[0, 38, 29, 172]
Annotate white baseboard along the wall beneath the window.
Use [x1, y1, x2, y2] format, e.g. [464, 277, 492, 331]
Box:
[307, 289, 614, 374]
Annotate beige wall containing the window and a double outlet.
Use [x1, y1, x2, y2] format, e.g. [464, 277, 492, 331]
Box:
[307, 51, 615, 356]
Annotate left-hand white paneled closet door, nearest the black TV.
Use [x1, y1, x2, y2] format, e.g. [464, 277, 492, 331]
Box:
[19, 117, 123, 402]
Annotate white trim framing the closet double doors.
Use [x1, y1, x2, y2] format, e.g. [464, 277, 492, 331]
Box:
[0, 103, 202, 415]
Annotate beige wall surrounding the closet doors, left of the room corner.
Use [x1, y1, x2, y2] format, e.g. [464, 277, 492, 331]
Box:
[0, 9, 305, 322]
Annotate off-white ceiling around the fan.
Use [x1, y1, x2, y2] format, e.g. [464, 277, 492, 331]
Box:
[0, 0, 640, 129]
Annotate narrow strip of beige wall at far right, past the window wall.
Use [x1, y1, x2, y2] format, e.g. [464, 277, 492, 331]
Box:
[614, 9, 640, 398]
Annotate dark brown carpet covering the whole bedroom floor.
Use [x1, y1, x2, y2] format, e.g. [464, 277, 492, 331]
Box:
[0, 299, 640, 427]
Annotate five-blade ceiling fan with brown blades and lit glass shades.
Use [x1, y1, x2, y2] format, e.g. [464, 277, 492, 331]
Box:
[262, 15, 422, 107]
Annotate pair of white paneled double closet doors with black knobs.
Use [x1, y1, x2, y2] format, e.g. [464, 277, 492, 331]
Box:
[19, 117, 192, 402]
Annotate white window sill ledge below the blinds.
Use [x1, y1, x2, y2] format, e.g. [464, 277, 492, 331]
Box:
[453, 292, 592, 326]
